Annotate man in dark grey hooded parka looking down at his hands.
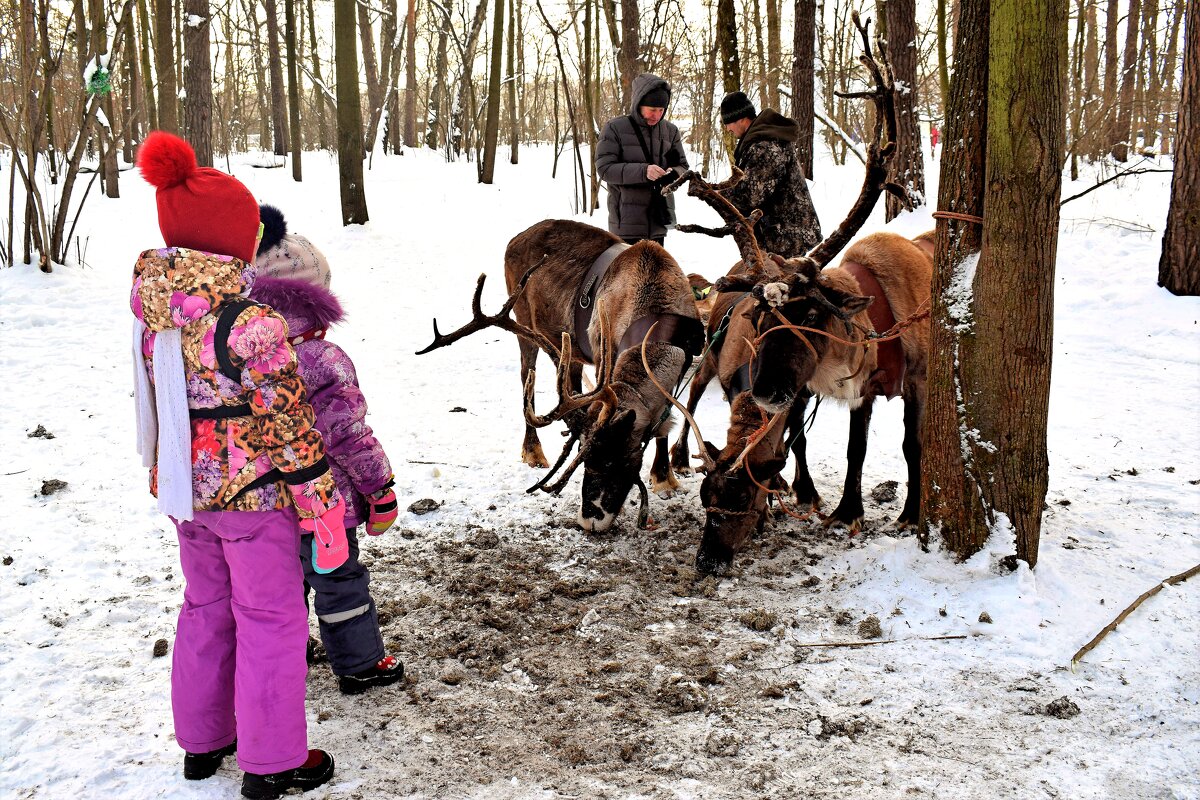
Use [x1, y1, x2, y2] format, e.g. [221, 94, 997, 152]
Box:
[596, 72, 688, 245]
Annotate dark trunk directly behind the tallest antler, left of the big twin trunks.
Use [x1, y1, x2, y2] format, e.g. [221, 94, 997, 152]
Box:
[887, 0, 925, 221]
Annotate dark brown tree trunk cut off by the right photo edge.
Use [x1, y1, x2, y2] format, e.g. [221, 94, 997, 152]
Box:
[1158, 2, 1200, 296]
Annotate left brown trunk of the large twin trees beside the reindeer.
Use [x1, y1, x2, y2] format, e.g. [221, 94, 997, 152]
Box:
[918, 0, 989, 559]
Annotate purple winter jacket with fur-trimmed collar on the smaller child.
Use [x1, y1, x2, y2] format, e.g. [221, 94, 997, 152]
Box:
[250, 276, 391, 529]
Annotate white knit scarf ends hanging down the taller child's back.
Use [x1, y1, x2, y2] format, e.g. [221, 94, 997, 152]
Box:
[133, 319, 192, 522]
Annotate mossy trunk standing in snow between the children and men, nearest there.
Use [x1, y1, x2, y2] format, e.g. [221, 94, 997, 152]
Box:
[334, 0, 368, 225]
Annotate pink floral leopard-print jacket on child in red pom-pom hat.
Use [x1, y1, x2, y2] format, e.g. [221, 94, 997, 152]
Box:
[130, 247, 340, 518]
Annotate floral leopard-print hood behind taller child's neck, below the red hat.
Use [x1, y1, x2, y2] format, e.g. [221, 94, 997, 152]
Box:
[130, 247, 257, 332]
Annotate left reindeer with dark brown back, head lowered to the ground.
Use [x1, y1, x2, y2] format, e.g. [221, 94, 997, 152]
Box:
[420, 219, 703, 531]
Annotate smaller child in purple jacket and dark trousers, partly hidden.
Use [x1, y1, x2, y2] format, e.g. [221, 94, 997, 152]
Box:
[251, 205, 404, 694]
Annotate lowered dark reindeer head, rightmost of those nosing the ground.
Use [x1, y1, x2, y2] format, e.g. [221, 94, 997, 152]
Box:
[696, 392, 787, 575]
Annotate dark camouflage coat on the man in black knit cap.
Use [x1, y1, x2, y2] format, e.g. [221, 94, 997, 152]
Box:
[726, 108, 821, 258]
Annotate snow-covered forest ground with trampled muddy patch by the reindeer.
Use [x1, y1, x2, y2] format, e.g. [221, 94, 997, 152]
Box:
[0, 150, 1200, 800]
